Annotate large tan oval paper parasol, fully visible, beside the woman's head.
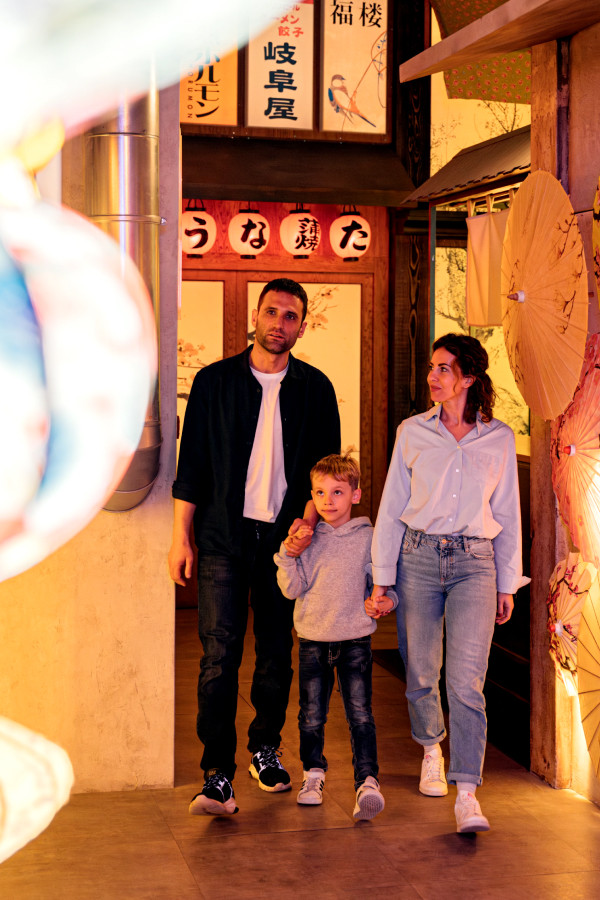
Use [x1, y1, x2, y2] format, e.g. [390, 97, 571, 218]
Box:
[501, 172, 588, 419]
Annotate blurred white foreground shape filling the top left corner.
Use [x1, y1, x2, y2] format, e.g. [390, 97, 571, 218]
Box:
[0, 0, 293, 153]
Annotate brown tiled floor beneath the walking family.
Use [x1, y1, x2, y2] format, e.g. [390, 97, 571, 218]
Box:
[0, 610, 600, 900]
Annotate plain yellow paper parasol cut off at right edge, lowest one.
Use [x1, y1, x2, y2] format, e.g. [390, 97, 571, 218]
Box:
[577, 597, 600, 777]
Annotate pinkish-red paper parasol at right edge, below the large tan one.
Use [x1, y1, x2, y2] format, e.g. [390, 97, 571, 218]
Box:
[550, 334, 600, 568]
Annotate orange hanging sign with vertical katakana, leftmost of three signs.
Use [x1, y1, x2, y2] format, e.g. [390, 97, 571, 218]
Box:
[179, 50, 238, 125]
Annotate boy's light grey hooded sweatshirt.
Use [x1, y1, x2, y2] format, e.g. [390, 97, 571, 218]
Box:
[273, 516, 398, 641]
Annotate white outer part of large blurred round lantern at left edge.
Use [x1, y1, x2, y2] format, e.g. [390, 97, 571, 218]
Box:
[0, 167, 157, 580]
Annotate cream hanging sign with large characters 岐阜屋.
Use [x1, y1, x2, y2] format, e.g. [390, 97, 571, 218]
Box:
[246, 0, 314, 130]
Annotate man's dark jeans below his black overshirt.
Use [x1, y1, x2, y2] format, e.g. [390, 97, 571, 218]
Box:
[197, 519, 294, 779]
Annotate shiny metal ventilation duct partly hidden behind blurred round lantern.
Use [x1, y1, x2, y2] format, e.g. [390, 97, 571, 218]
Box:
[83, 91, 162, 512]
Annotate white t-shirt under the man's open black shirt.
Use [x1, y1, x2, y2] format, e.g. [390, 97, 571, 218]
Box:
[244, 366, 287, 522]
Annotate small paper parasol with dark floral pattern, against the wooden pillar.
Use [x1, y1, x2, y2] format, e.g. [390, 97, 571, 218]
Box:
[546, 553, 600, 696]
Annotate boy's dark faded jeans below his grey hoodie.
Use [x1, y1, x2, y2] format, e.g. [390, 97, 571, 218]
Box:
[298, 635, 379, 789]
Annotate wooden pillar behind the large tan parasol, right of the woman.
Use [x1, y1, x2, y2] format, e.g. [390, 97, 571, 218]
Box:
[530, 41, 571, 788]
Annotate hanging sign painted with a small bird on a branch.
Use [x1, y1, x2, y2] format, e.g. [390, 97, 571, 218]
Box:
[321, 0, 388, 134]
